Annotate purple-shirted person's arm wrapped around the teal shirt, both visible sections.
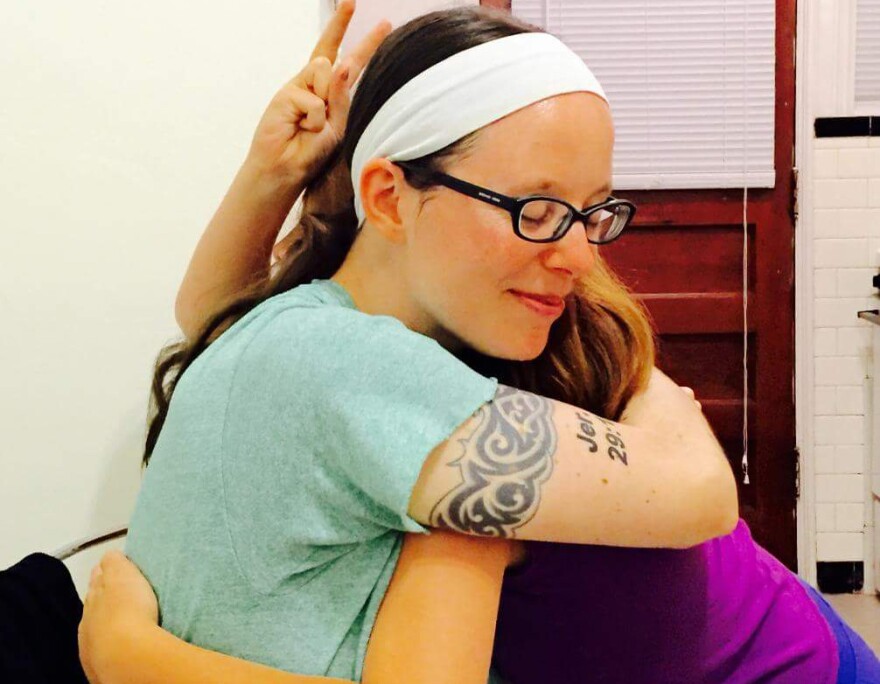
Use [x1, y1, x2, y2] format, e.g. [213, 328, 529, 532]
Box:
[80, 531, 514, 684]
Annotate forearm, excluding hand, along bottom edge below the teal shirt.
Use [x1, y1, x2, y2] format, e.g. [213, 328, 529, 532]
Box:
[102, 625, 351, 684]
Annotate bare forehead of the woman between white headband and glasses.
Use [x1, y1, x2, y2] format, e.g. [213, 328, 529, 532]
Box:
[458, 93, 614, 190]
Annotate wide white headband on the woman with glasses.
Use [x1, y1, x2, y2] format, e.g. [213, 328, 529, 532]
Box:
[351, 32, 608, 225]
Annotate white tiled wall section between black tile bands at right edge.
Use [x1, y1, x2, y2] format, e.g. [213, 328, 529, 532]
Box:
[804, 138, 880, 561]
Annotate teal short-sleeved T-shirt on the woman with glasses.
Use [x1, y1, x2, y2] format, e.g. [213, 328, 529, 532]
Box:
[126, 280, 497, 680]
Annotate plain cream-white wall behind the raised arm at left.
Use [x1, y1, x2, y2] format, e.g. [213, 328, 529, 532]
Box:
[0, 0, 477, 589]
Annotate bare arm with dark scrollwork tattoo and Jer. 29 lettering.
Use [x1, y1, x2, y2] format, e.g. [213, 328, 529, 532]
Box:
[409, 369, 738, 548]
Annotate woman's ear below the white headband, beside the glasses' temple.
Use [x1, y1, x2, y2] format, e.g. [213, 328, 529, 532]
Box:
[360, 157, 412, 244]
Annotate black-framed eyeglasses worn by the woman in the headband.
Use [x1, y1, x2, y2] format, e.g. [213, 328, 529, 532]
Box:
[394, 161, 636, 245]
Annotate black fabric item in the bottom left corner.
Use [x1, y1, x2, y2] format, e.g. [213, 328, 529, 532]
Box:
[0, 553, 88, 684]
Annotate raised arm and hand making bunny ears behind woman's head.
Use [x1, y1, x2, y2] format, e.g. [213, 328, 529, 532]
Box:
[175, 0, 391, 338]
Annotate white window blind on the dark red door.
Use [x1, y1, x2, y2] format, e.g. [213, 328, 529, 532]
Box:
[512, 0, 772, 190]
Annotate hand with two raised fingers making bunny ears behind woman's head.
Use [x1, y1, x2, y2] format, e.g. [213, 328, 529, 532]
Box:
[246, 0, 391, 186]
